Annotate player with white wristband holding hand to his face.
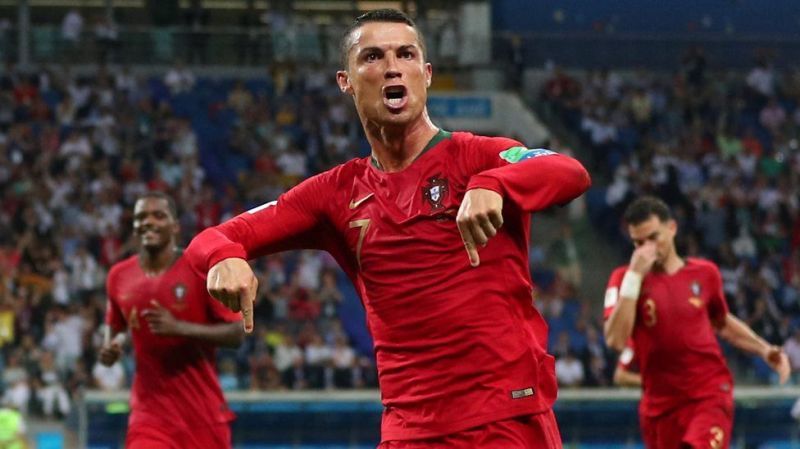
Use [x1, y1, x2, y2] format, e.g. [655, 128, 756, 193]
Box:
[605, 197, 790, 449]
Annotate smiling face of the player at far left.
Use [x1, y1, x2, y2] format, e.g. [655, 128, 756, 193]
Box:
[133, 198, 178, 251]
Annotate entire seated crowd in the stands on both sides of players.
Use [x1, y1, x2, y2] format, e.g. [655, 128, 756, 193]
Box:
[0, 43, 800, 424]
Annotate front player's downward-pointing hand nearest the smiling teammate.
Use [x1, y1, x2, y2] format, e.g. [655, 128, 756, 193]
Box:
[206, 258, 258, 332]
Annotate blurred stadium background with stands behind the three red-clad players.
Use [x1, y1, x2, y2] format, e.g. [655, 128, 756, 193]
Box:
[0, 0, 800, 449]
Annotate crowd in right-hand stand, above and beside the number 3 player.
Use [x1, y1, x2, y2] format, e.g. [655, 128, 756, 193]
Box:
[541, 48, 800, 381]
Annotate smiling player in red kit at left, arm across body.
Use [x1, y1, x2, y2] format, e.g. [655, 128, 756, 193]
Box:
[100, 192, 244, 449]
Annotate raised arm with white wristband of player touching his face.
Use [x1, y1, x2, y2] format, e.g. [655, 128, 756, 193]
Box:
[603, 241, 656, 351]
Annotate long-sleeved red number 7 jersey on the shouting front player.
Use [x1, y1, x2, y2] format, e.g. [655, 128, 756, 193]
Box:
[187, 132, 589, 441]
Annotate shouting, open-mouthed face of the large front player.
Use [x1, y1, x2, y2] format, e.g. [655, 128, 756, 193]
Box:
[336, 23, 432, 126]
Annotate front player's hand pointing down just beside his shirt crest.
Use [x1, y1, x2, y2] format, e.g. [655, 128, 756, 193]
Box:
[456, 189, 503, 267]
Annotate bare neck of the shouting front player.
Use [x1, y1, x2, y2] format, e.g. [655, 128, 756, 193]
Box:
[364, 111, 439, 173]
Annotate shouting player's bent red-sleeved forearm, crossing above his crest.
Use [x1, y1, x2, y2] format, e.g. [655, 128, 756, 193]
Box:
[467, 155, 591, 212]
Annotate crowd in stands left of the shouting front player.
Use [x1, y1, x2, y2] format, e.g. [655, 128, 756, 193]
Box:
[0, 59, 377, 416]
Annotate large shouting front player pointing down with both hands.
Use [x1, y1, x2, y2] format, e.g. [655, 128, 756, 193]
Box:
[187, 10, 590, 449]
